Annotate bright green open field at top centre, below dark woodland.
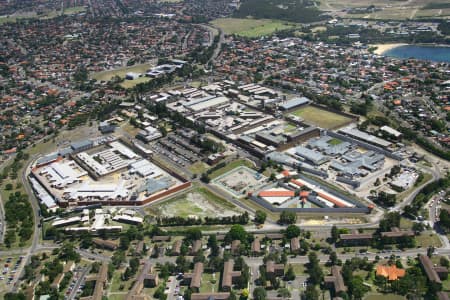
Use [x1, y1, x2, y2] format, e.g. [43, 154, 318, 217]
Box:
[211, 18, 295, 37]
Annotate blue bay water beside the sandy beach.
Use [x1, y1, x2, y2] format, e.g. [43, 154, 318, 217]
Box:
[383, 45, 450, 62]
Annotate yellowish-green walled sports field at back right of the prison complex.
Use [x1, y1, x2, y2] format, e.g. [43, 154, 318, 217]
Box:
[291, 106, 351, 129]
